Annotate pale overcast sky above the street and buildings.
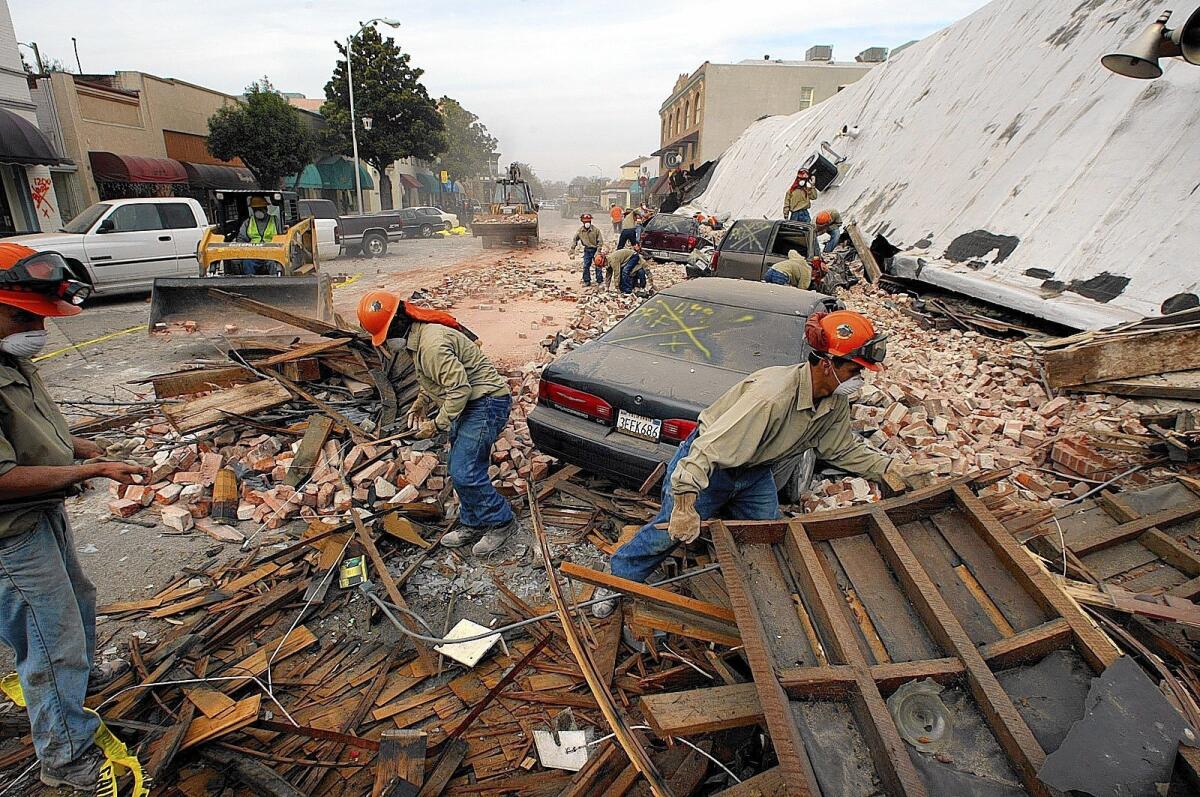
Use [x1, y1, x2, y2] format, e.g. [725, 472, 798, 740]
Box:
[8, 0, 984, 179]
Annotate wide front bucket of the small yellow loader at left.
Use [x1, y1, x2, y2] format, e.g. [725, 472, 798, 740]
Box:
[149, 275, 334, 336]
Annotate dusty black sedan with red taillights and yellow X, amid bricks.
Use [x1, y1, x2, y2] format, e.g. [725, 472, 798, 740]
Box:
[528, 280, 838, 486]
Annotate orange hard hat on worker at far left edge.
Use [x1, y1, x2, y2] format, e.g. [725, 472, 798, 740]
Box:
[0, 244, 83, 318]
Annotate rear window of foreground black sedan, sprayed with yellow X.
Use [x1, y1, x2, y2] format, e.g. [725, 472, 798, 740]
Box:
[600, 294, 804, 373]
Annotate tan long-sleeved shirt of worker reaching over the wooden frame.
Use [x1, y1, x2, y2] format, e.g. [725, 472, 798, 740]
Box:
[671, 362, 890, 495]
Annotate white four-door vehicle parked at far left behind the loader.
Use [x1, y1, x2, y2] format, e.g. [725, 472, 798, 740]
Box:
[5, 198, 209, 295]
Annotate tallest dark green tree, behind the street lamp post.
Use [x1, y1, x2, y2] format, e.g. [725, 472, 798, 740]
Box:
[320, 28, 446, 209]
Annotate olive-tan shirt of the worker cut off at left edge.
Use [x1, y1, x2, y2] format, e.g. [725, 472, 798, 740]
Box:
[0, 354, 74, 538]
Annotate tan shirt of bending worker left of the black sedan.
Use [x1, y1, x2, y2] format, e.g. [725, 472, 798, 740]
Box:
[407, 322, 512, 432]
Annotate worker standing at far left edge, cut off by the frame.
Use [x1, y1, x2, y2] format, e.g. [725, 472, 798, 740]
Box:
[0, 242, 145, 793]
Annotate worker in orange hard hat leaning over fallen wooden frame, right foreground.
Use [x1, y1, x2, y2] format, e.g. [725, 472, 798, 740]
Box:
[593, 310, 922, 617]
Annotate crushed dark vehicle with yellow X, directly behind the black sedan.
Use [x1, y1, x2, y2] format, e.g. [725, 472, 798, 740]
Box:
[686, 218, 820, 281]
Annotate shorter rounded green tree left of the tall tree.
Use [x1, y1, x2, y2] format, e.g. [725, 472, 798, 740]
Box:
[209, 77, 313, 188]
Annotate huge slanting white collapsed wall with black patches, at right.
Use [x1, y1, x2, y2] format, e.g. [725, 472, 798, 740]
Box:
[696, 0, 1200, 328]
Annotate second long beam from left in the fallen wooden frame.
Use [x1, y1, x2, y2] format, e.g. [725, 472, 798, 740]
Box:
[786, 521, 928, 797]
